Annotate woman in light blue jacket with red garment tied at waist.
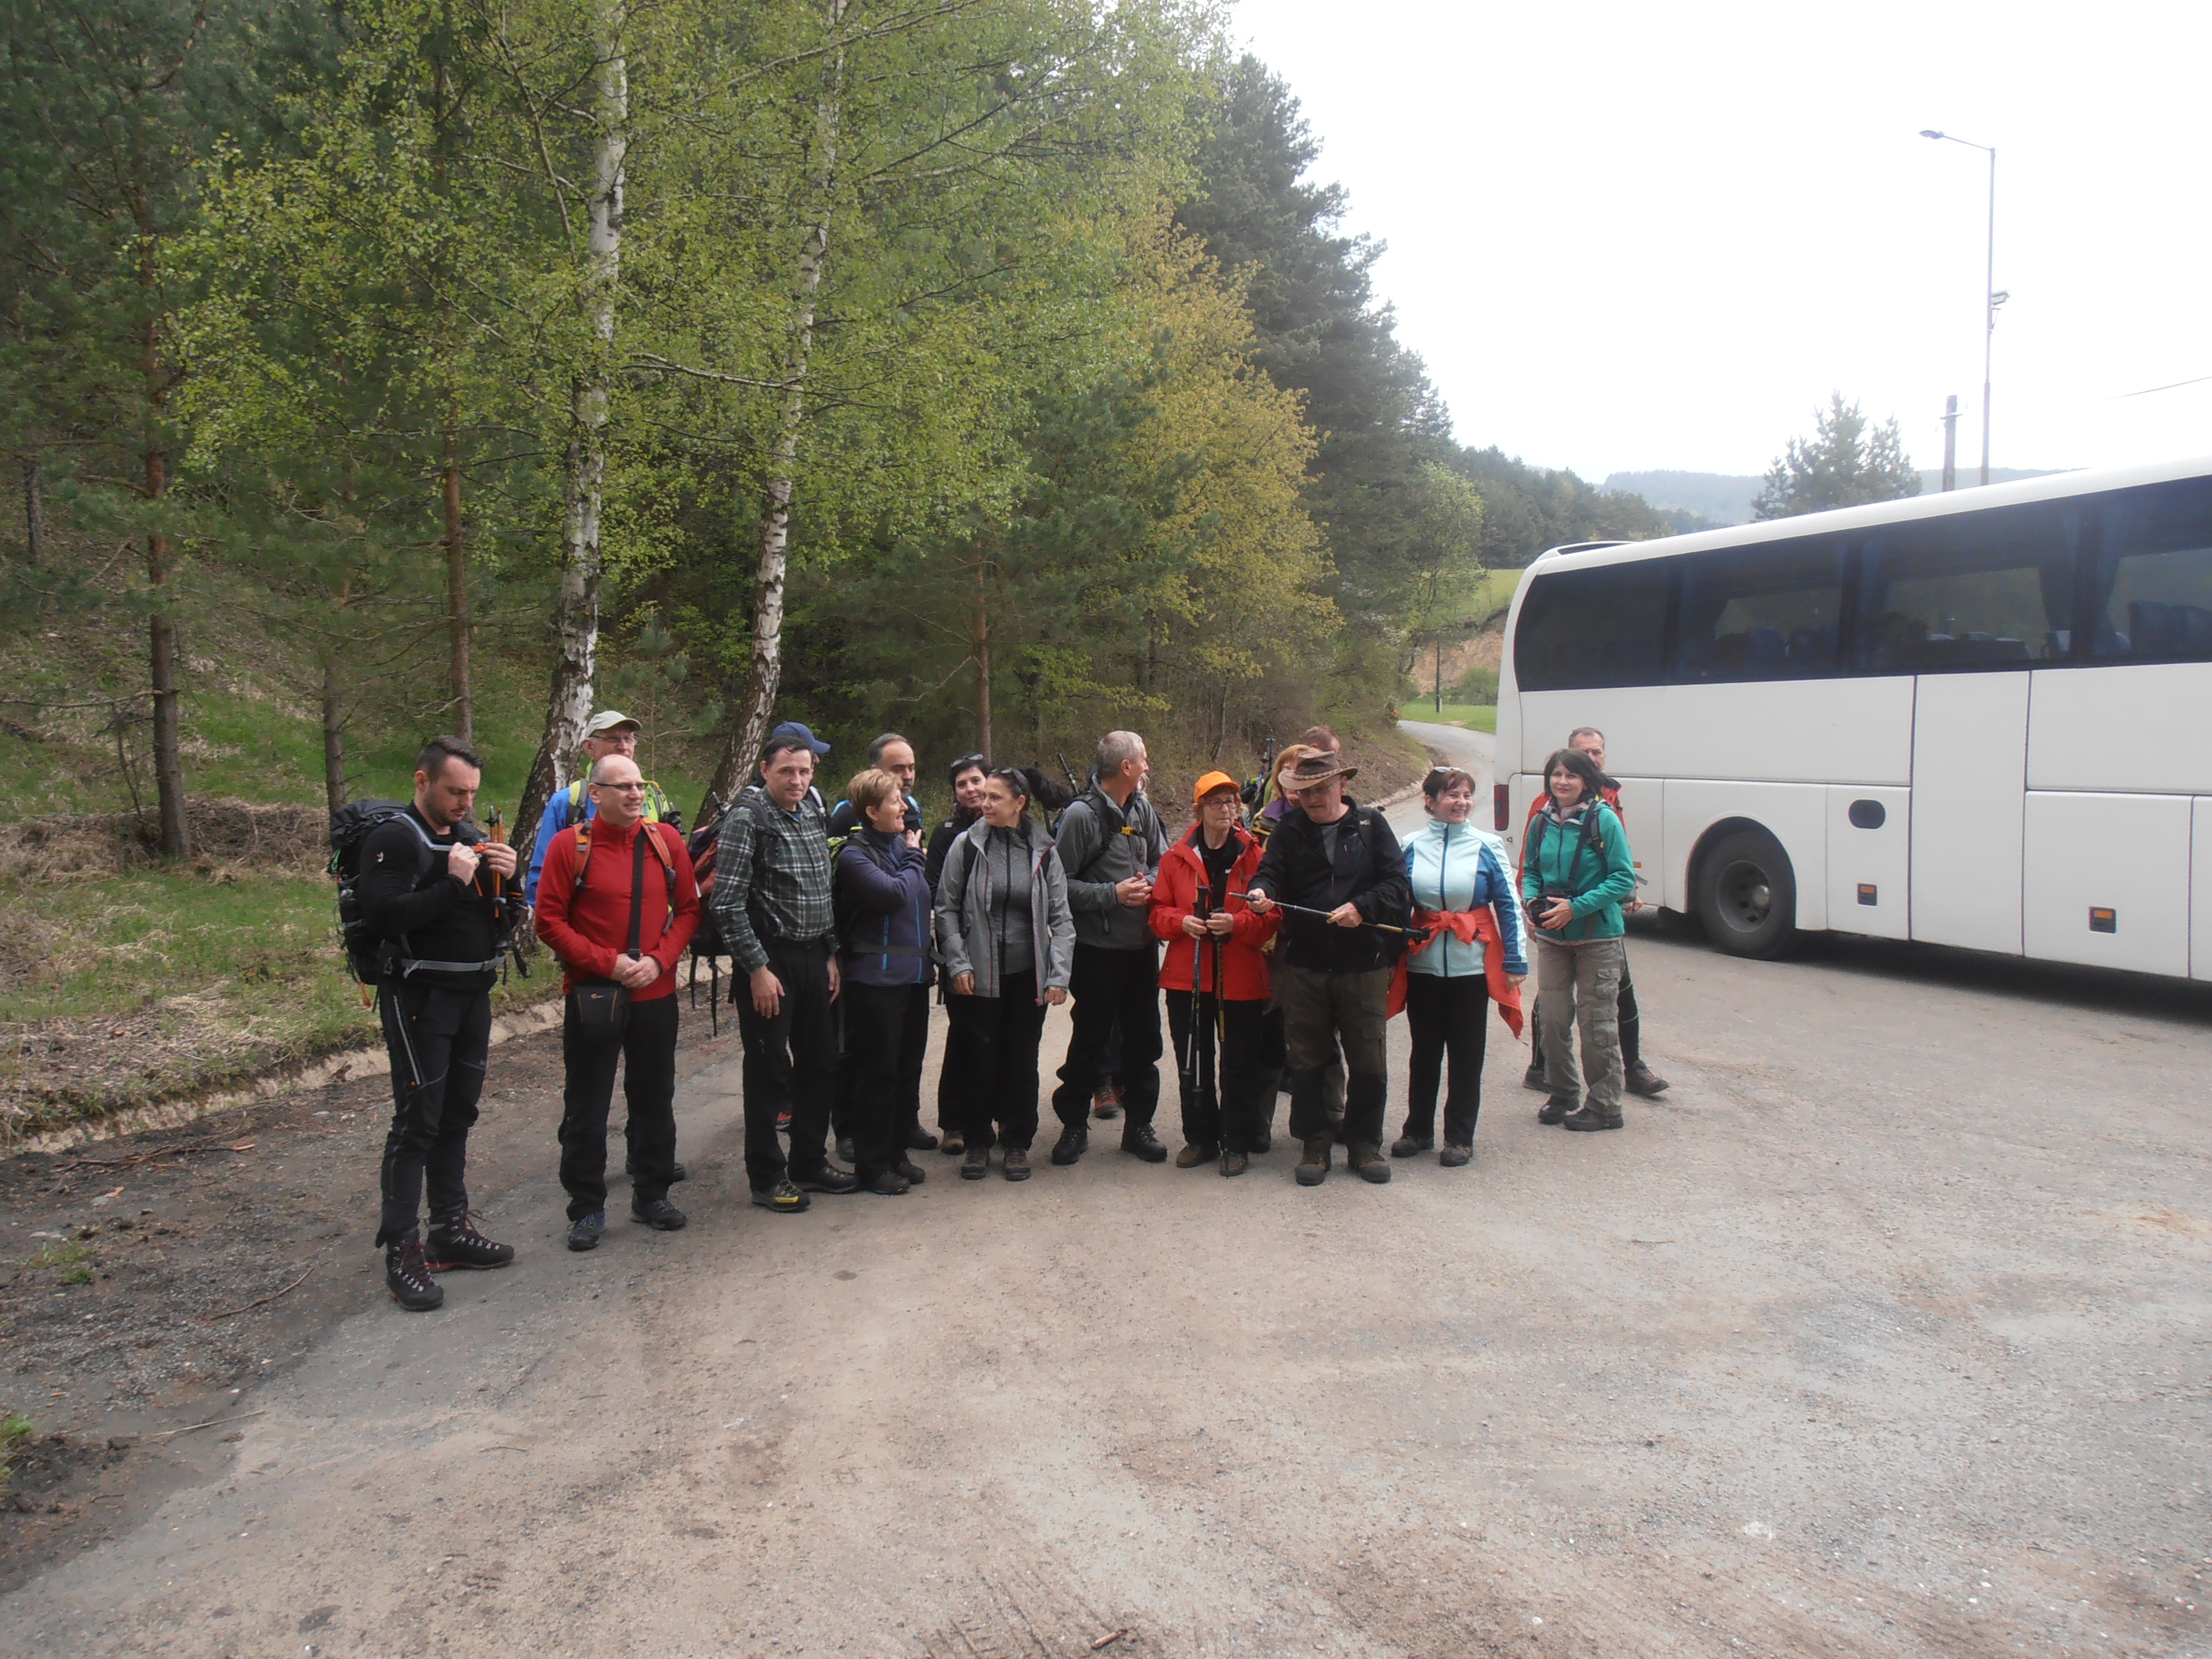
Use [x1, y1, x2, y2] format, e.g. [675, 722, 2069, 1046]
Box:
[1389, 768, 1528, 1168]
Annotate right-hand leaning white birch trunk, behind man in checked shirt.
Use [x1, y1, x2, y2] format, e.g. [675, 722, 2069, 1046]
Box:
[699, 0, 847, 819]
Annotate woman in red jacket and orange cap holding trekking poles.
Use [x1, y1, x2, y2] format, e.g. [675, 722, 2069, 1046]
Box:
[1152, 772, 1281, 1175]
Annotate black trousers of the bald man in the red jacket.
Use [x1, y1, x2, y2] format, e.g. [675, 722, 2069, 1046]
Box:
[560, 991, 677, 1221]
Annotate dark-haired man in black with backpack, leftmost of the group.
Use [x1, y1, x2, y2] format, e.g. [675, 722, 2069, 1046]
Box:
[356, 737, 520, 1312]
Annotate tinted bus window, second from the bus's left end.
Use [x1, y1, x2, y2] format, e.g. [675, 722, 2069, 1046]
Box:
[1674, 540, 1843, 684]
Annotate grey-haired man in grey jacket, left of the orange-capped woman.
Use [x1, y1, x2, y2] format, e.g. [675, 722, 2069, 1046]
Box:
[1053, 732, 1168, 1163]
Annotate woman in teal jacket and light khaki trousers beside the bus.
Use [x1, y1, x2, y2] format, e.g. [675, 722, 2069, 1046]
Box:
[1522, 750, 1637, 1128]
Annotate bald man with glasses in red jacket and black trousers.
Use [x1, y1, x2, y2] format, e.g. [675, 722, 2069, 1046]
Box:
[538, 754, 699, 1250]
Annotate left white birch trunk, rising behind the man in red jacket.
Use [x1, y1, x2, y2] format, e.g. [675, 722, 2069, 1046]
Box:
[515, 5, 630, 834]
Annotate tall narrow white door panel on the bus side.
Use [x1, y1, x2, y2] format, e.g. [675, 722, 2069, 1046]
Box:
[1911, 673, 2028, 955]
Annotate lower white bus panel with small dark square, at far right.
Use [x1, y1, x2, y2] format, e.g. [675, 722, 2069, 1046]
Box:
[2022, 790, 2190, 975]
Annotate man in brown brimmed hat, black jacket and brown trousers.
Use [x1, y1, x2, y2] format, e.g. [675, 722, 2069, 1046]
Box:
[1252, 752, 1413, 1185]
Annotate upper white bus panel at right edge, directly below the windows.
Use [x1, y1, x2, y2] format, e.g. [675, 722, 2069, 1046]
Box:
[2028, 661, 2212, 794]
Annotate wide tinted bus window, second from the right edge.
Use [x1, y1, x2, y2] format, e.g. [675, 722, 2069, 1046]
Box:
[1853, 502, 2081, 675]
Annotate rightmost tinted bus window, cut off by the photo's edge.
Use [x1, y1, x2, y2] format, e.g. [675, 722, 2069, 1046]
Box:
[2088, 478, 2212, 661]
